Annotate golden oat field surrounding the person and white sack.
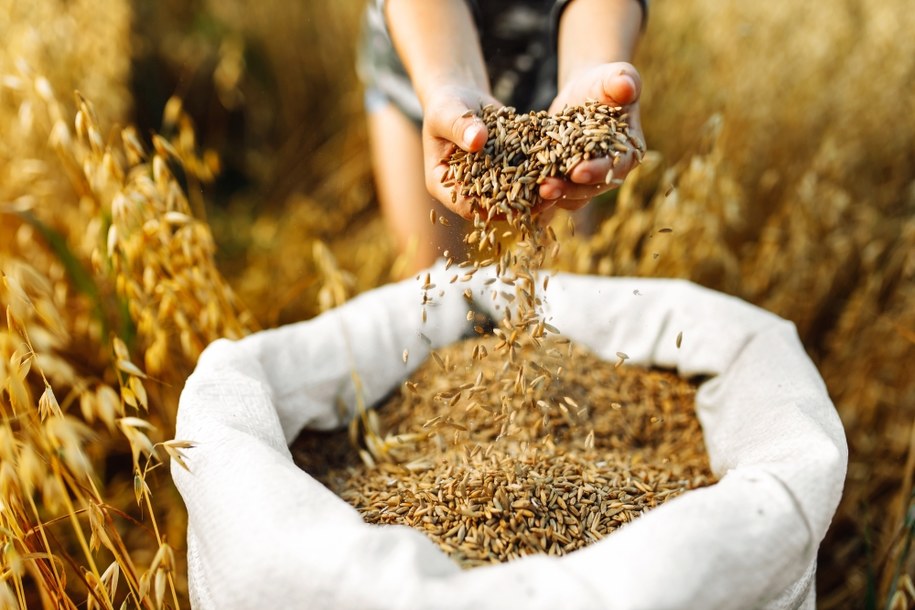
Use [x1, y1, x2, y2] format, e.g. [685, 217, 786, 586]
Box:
[0, 0, 915, 608]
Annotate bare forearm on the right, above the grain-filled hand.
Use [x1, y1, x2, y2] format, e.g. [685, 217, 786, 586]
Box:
[558, 0, 643, 88]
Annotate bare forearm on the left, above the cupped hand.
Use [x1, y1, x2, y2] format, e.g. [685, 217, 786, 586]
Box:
[385, 0, 490, 107]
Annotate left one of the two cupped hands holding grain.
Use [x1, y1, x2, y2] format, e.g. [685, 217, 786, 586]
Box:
[423, 86, 502, 219]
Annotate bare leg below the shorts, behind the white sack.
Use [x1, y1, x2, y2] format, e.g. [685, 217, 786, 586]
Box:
[368, 103, 464, 276]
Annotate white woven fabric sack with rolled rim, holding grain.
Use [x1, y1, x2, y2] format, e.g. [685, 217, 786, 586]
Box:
[172, 265, 848, 610]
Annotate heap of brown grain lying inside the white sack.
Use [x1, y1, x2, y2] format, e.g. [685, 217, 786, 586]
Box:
[293, 336, 713, 567]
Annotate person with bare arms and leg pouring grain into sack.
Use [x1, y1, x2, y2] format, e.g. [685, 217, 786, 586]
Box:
[358, 0, 647, 275]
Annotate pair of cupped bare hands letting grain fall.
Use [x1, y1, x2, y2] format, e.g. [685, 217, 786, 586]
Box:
[422, 62, 644, 219]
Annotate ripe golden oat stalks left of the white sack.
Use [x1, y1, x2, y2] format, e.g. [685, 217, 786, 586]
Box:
[0, 1, 253, 608]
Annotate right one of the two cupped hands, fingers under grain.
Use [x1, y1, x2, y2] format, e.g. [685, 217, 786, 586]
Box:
[540, 62, 645, 210]
